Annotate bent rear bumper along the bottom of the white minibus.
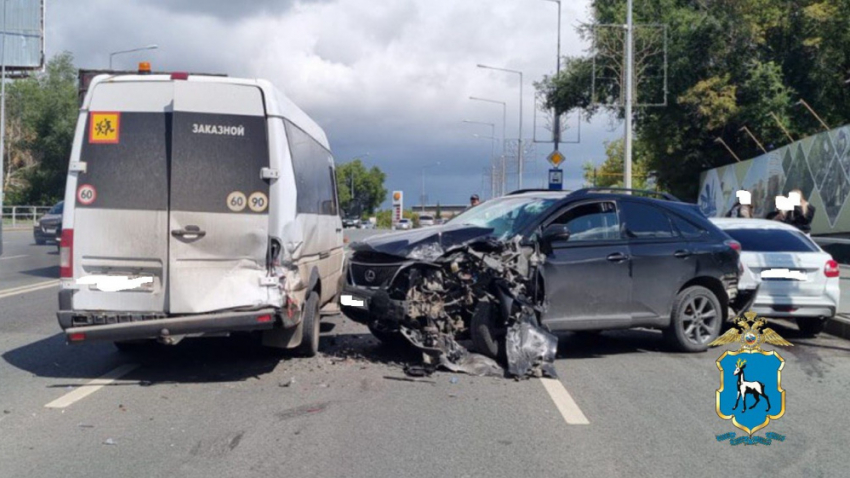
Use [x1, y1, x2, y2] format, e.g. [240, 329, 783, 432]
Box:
[57, 309, 278, 343]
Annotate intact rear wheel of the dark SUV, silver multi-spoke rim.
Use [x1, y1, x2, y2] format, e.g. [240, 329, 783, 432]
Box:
[664, 285, 723, 352]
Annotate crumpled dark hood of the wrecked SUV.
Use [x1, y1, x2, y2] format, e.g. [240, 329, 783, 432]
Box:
[351, 224, 493, 261]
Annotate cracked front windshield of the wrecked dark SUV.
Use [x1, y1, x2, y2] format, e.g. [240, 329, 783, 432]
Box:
[448, 197, 557, 239]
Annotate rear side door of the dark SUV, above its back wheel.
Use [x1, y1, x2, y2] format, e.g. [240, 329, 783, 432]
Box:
[620, 199, 697, 325]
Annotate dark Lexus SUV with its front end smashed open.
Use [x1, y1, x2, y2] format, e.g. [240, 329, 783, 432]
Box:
[341, 188, 746, 376]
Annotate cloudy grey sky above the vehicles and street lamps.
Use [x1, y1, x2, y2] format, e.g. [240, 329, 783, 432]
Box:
[46, 0, 621, 206]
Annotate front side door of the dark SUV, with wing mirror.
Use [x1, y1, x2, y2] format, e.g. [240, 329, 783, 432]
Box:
[542, 201, 632, 330]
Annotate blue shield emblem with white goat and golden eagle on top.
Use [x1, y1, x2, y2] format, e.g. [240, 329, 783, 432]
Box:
[709, 312, 792, 445]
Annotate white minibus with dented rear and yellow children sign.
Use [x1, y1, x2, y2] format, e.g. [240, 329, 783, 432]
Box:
[57, 73, 345, 356]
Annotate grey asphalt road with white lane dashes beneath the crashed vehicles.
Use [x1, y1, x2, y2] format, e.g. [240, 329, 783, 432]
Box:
[0, 231, 850, 478]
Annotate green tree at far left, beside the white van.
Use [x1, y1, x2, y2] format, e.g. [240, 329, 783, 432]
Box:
[3, 52, 79, 205]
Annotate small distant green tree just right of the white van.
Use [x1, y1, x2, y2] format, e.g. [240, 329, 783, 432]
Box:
[336, 159, 387, 217]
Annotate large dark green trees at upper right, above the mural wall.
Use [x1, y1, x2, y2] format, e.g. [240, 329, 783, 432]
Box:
[537, 0, 850, 199]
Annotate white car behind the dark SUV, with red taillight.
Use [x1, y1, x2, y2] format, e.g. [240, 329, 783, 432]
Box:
[711, 218, 841, 336]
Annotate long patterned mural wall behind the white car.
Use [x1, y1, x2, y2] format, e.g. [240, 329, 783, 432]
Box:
[699, 125, 850, 235]
